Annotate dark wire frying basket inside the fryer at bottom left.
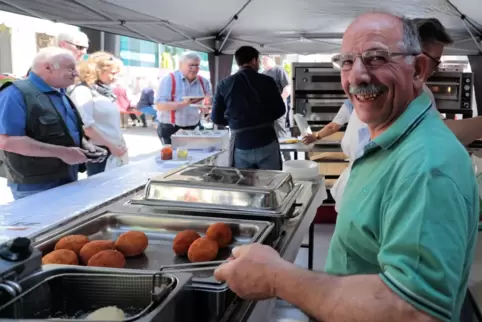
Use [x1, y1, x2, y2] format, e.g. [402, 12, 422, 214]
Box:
[0, 273, 176, 321]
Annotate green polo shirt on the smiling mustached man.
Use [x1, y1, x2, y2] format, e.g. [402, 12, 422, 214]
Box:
[325, 94, 479, 321]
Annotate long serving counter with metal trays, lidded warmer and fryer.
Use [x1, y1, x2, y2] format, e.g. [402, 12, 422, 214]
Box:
[0, 152, 327, 322]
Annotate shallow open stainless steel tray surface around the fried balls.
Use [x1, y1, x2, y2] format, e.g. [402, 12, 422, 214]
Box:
[33, 212, 274, 285]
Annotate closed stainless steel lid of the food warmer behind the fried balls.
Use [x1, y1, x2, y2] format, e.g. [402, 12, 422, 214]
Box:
[128, 165, 301, 214]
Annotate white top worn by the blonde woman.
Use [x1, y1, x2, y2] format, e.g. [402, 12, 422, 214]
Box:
[70, 86, 123, 145]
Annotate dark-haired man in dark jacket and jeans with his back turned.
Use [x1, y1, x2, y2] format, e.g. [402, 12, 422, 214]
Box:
[211, 46, 286, 170]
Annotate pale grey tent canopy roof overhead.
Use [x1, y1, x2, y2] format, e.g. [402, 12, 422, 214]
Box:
[0, 0, 482, 55]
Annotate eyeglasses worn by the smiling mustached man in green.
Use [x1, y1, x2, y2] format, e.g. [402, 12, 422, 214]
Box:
[331, 50, 420, 71]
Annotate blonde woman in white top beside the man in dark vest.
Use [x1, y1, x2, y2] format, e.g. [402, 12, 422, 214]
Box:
[70, 52, 127, 176]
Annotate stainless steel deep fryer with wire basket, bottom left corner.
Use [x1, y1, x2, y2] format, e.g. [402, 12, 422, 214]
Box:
[0, 265, 191, 322]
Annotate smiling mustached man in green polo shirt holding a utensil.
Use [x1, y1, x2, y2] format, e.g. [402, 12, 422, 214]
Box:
[215, 13, 479, 322]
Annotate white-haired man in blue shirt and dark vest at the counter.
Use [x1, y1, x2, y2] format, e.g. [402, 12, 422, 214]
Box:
[0, 47, 101, 199]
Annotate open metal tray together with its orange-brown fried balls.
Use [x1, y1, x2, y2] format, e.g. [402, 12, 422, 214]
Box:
[34, 211, 273, 284]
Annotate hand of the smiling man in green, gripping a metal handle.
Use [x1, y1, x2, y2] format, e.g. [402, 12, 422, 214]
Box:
[214, 244, 292, 300]
